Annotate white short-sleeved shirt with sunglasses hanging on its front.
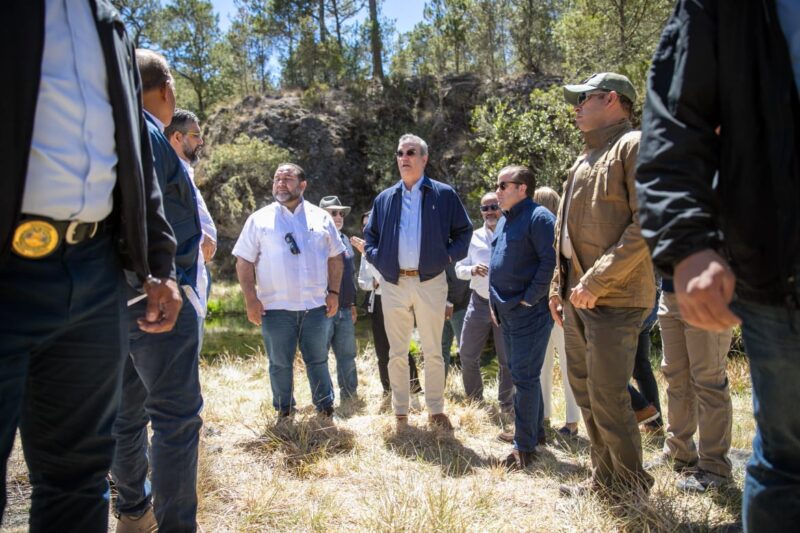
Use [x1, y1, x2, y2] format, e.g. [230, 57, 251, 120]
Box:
[233, 200, 344, 311]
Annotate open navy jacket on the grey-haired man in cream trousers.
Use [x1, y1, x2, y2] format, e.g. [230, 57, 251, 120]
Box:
[364, 176, 472, 284]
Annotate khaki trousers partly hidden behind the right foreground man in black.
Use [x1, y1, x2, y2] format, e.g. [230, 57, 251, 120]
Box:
[658, 292, 733, 477]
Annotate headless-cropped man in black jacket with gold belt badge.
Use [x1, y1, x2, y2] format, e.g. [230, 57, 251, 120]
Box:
[0, 0, 181, 532]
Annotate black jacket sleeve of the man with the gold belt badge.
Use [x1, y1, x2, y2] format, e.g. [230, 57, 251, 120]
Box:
[131, 50, 176, 279]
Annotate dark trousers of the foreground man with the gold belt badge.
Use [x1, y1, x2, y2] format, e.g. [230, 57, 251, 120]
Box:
[0, 230, 128, 532]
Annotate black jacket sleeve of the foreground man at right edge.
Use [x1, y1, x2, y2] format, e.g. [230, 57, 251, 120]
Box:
[636, 0, 720, 275]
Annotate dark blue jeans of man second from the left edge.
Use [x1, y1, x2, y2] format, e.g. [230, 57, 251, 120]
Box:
[111, 298, 203, 531]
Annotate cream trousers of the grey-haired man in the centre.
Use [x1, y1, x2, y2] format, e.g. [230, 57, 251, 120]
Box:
[381, 272, 447, 415]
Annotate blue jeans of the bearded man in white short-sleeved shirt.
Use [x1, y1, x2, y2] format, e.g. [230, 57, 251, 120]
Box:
[261, 306, 334, 414]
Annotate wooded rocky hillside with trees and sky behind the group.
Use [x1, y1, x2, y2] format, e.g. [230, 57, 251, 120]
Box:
[112, 0, 674, 277]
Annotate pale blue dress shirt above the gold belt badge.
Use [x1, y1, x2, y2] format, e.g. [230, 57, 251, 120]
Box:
[22, 0, 117, 222]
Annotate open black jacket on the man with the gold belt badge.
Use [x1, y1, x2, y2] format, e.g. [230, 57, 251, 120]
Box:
[0, 0, 175, 279]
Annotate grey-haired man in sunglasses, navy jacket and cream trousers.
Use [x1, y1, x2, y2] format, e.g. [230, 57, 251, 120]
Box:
[364, 134, 472, 429]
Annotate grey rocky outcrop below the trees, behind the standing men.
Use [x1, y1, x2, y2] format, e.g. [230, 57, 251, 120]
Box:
[198, 74, 559, 277]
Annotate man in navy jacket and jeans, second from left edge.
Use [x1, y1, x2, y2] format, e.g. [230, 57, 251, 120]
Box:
[111, 50, 203, 531]
